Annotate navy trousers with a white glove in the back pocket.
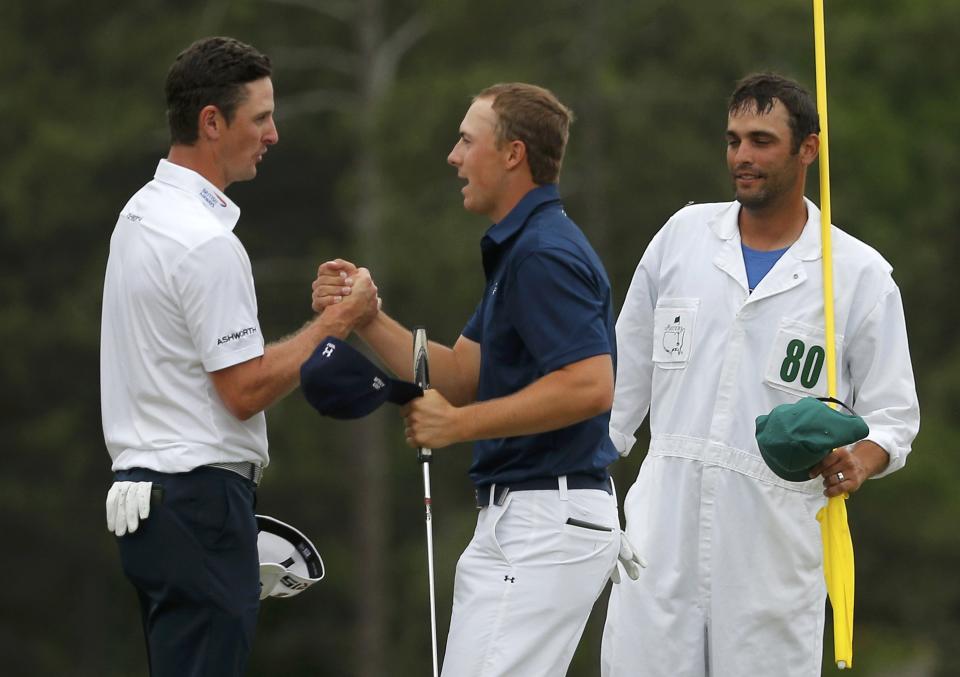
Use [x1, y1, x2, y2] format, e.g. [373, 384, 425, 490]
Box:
[116, 467, 260, 677]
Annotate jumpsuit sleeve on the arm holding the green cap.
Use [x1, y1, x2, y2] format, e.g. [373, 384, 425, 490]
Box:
[847, 280, 920, 477]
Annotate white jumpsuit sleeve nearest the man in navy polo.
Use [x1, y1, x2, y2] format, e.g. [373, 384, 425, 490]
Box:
[610, 230, 663, 456]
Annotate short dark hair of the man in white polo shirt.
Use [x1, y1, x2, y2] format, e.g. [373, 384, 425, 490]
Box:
[164, 37, 271, 146]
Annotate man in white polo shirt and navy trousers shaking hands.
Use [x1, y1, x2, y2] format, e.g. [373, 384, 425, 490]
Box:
[100, 38, 377, 677]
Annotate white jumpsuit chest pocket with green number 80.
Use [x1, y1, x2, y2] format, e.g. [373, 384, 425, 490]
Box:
[764, 318, 843, 397]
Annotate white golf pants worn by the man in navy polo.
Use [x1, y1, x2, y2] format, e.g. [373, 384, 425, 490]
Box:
[442, 478, 620, 677]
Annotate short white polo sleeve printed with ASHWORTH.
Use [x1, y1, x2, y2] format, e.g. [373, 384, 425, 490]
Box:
[173, 234, 263, 372]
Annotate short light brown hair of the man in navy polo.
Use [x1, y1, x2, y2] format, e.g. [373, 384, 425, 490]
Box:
[473, 82, 573, 186]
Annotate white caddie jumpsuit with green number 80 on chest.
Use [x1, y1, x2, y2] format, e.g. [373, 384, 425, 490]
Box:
[601, 201, 919, 677]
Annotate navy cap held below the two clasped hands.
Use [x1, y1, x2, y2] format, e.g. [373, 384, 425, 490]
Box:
[300, 336, 423, 418]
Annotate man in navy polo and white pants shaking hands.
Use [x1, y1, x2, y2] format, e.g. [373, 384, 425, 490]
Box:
[314, 83, 632, 677]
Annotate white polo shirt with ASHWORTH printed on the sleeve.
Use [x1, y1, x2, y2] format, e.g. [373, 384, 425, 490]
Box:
[100, 160, 269, 473]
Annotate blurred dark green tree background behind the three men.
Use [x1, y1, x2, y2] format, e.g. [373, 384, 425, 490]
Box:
[0, 0, 960, 677]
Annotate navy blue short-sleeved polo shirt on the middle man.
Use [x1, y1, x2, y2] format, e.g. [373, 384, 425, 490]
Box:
[463, 184, 617, 486]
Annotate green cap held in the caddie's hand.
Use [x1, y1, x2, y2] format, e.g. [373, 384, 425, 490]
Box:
[757, 397, 870, 482]
